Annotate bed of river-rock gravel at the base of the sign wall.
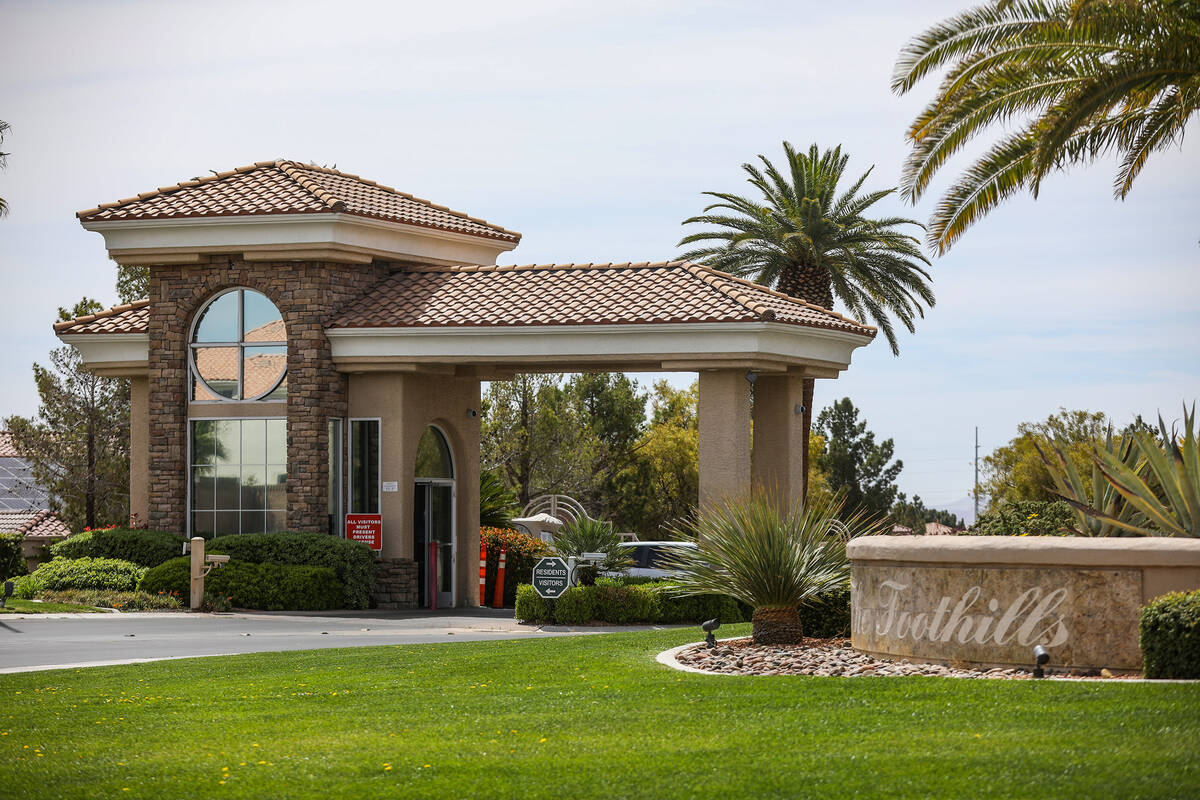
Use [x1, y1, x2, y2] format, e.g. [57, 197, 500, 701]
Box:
[676, 638, 1121, 680]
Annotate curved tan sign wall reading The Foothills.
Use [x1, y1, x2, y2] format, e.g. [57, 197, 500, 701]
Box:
[848, 536, 1200, 672]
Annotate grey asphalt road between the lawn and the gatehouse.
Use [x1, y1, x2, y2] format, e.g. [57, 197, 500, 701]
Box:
[0, 609, 657, 673]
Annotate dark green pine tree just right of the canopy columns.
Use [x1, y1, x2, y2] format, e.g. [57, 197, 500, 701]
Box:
[817, 397, 904, 516]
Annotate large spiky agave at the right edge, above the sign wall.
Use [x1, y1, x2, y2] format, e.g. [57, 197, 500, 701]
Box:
[1073, 403, 1200, 536]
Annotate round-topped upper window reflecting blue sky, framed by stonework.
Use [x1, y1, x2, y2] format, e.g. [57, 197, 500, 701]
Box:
[191, 289, 288, 401]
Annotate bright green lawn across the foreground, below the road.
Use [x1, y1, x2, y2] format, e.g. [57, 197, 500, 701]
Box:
[0, 626, 1200, 800]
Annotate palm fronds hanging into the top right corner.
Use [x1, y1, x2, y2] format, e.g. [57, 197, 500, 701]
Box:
[892, 0, 1200, 253]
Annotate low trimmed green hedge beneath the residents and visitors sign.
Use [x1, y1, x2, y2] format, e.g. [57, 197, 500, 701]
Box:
[515, 578, 749, 625]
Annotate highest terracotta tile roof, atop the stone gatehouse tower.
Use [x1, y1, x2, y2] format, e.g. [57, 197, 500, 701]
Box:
[76, 160, 521, 242]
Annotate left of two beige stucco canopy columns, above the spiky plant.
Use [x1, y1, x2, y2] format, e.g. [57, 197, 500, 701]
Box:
[697, 369, 750, 506]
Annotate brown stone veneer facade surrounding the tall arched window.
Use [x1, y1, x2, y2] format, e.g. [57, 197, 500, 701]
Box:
[148, 255, 388, 531]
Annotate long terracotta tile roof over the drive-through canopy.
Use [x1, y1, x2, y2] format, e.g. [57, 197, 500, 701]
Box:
[330, 261, 875, 336]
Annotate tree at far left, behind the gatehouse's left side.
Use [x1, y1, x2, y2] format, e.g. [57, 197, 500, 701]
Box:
[5, 297, 130, 530]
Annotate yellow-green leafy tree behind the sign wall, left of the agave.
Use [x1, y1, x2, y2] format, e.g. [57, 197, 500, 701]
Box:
[982, 409, 1109, 507]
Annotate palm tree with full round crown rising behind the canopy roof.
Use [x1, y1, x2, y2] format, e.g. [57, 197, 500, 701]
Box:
[679, 142, 934, 497]
